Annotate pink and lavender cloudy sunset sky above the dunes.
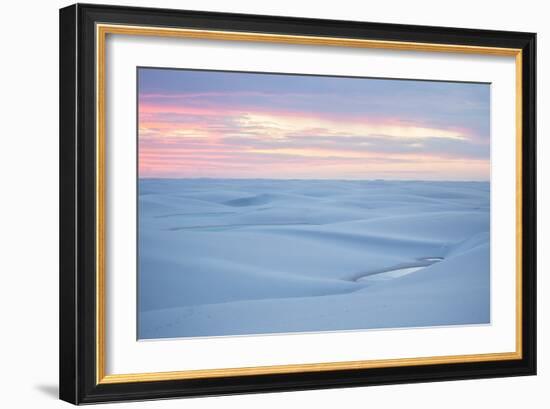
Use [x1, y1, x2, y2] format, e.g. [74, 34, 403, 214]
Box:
[138, 68, 490, 181]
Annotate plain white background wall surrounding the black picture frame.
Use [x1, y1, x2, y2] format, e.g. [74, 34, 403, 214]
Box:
[0, 0, 550, 408]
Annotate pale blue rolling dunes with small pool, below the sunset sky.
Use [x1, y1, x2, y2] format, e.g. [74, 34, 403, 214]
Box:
[138, 179, 490, 339]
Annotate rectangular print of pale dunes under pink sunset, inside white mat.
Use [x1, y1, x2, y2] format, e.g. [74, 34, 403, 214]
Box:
[137, 68, 490, 339]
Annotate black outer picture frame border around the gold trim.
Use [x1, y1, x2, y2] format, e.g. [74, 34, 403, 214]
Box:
[59, 4, 536, 404]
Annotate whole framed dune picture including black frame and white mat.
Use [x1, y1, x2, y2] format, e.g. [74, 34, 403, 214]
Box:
[60, 5, 536, 404]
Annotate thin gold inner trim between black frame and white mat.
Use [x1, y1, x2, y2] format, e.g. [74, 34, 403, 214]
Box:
[96, 24, 523, 384]
